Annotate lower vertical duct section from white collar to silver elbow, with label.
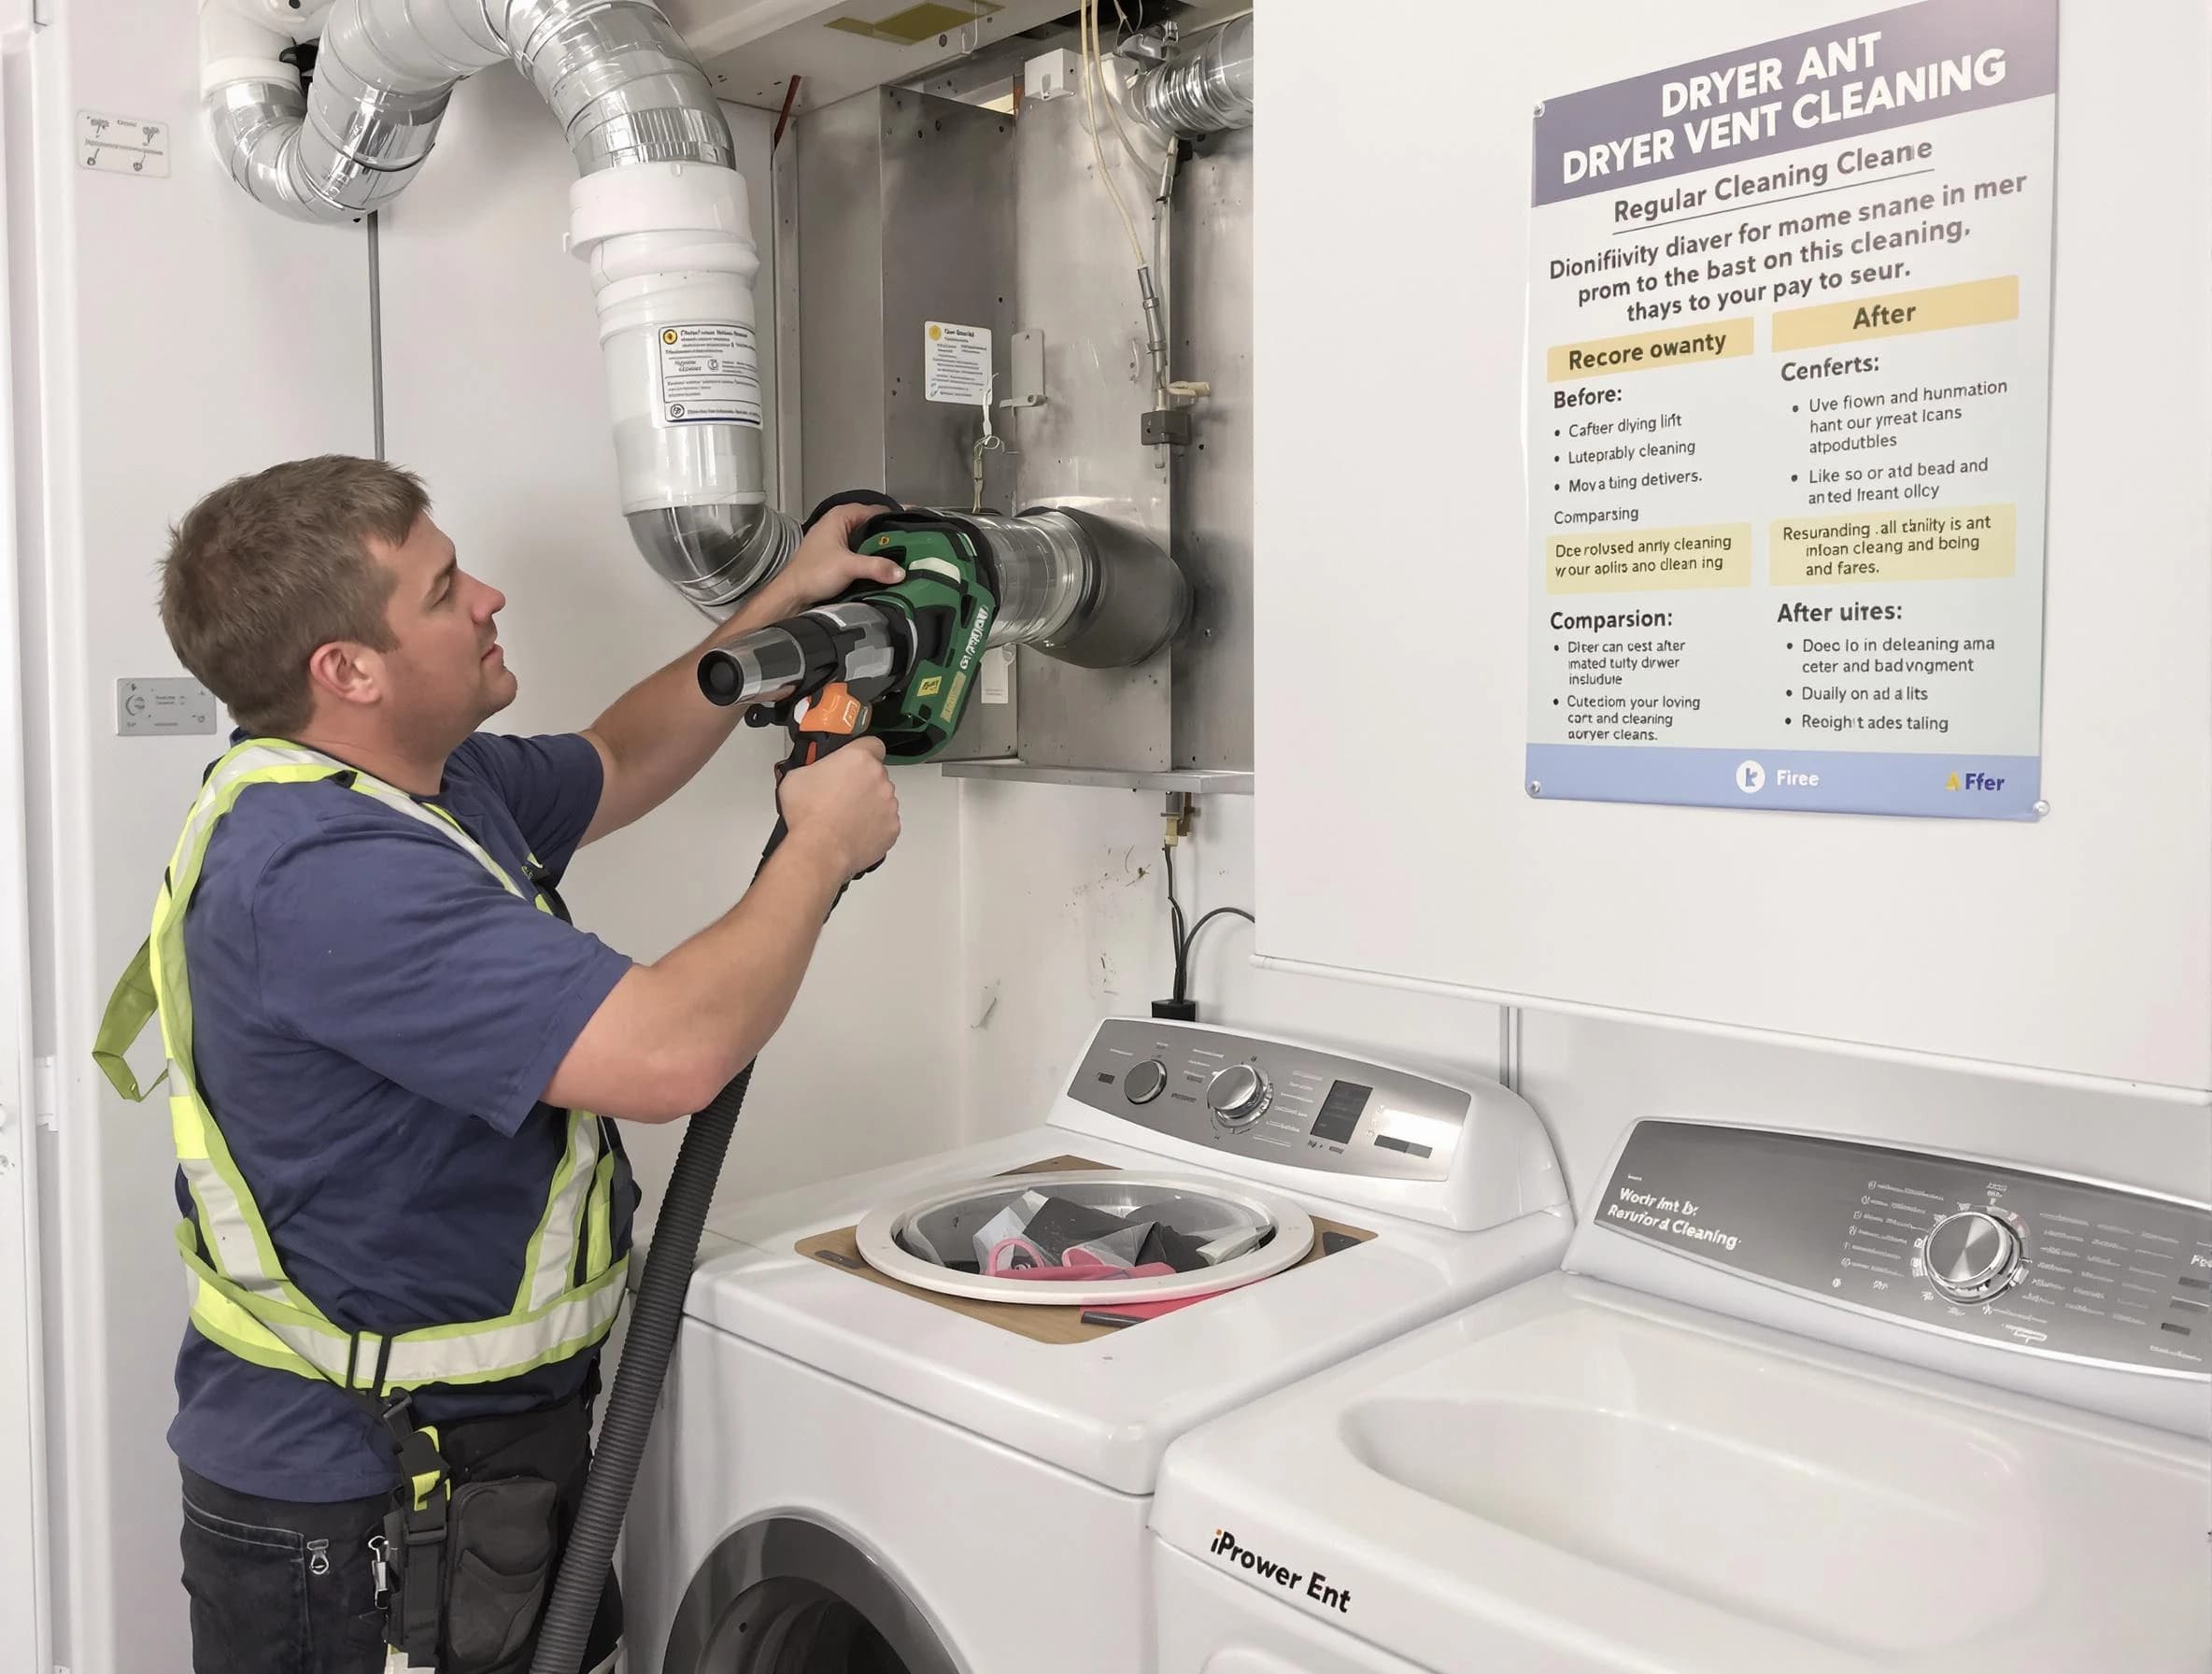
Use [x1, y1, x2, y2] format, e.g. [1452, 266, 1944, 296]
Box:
[569, 163, 799, 613]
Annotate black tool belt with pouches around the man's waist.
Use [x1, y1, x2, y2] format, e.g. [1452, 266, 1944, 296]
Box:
[369, 1389, 621, 1674]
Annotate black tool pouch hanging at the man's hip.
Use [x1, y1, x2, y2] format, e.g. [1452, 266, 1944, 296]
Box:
[438, 1477, 560, 1674]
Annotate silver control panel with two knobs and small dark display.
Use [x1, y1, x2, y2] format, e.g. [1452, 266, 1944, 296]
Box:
[1069, 1019, 1471, 1181]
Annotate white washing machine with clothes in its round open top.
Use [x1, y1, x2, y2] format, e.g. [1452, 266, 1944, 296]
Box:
[624, 1019, 1573, 1674]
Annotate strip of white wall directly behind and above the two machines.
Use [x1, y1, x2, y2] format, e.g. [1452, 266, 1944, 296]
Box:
[962, 781, 2212, 1208]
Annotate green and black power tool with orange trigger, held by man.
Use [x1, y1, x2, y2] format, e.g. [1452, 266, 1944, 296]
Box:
[699, 511, 998, 776]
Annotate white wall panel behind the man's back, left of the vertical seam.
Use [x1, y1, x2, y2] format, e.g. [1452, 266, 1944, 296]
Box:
[16, 0, 369, 1674]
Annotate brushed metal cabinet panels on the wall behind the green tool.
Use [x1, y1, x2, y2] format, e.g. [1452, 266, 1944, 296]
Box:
[779, 75, 1252, 787]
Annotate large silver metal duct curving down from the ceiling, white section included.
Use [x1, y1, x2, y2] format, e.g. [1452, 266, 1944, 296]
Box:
[199, 0, 799, 615]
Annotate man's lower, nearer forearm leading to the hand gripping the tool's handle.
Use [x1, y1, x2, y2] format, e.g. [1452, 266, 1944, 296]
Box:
[546, 841, 847, 1121]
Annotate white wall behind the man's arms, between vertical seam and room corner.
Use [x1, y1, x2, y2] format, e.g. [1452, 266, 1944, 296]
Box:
[380, 66, 960, 1212]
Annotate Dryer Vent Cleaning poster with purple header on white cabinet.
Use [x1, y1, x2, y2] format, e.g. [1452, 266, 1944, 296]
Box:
[1528, 0, 2057, 818]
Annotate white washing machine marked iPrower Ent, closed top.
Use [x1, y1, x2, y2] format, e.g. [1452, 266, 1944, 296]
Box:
[1153, 1121, 2212, 1674]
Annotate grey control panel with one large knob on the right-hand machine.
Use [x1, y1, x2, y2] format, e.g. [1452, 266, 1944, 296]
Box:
[1595, 1121, 2212, 1375]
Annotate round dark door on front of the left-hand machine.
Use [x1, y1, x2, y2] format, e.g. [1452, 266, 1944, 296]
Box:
[661, 1517, 969, 1674]
